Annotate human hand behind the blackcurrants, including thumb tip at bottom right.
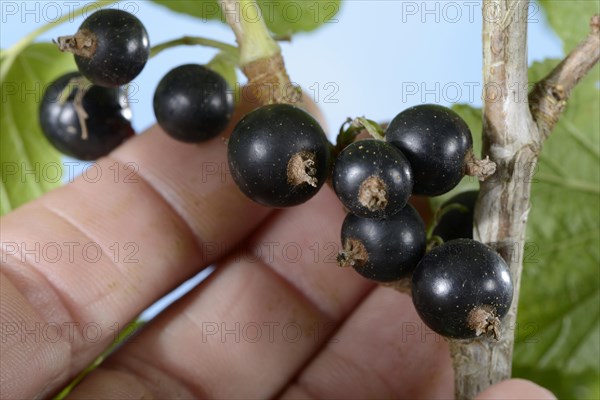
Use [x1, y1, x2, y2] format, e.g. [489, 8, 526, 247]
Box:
[0, 104, 552, 399]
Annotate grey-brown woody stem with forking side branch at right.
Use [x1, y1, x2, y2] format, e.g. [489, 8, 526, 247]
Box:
[450, 0, 600, 399]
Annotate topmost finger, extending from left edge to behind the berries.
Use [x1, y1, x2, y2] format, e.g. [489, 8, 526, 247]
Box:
[0, 116, 268, 398]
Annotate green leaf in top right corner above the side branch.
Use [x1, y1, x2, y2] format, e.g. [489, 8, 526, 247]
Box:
[539, 0, 600, 53]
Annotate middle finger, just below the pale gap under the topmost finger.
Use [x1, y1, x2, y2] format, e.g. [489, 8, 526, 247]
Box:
[69, 188, 372, 398]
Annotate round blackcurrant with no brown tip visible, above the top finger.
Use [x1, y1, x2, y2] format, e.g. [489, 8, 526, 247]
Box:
[154, 64, 233, 143]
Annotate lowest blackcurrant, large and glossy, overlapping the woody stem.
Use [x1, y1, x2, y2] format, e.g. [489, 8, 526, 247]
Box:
[412, 239, 513, 339]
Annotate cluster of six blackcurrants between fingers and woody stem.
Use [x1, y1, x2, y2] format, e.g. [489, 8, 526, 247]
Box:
[223, 104, 513, 339]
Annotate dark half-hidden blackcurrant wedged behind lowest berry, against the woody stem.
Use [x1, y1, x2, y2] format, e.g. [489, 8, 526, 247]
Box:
[433, 190, 479, 242]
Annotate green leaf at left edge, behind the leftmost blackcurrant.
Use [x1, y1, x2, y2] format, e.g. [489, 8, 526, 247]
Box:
[0, 43, 76, 215]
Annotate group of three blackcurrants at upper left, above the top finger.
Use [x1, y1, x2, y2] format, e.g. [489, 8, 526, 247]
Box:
[40, 9, 233, 160]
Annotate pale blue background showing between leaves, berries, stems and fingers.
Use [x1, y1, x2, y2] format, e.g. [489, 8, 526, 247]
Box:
[0, 0, 562, 315]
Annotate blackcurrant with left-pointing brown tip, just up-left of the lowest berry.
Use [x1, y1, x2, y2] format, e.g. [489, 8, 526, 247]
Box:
[338, 204, 426, 282]
